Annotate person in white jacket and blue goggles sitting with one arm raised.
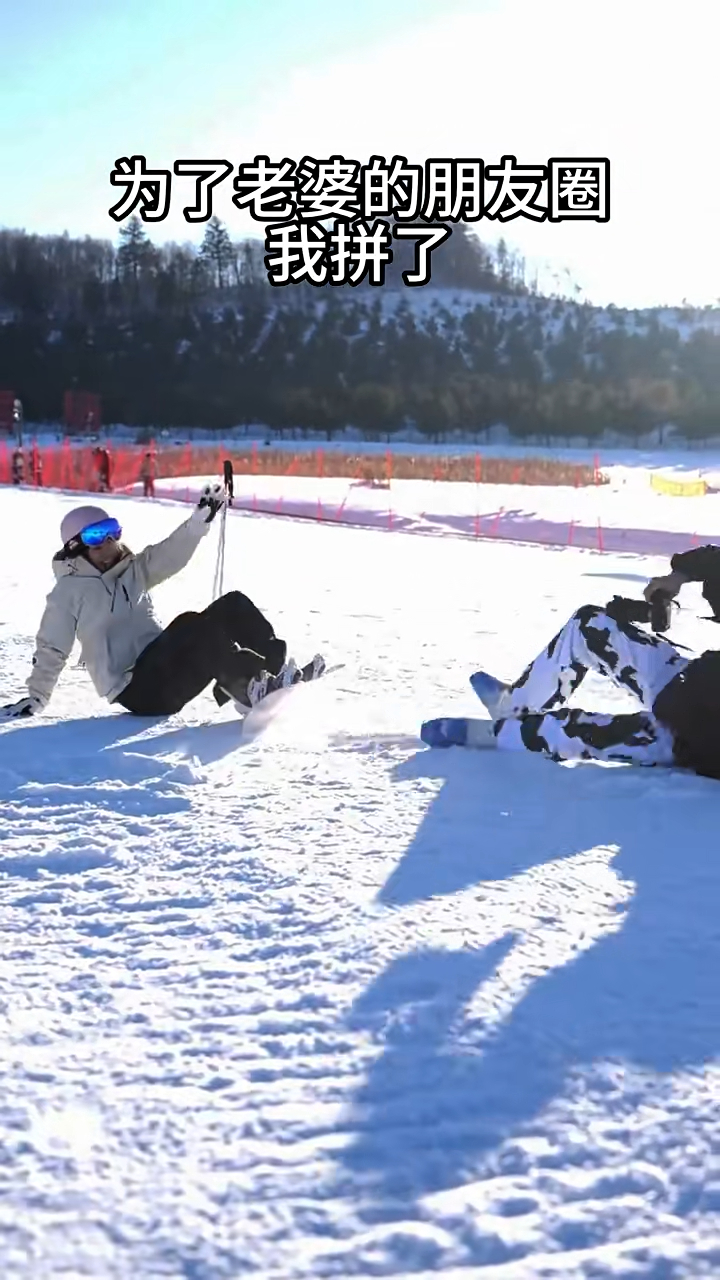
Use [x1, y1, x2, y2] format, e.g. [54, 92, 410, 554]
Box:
[0, 484, 313, 719]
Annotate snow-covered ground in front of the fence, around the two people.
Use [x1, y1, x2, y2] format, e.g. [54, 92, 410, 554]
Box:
[0, 490, 720, 1280]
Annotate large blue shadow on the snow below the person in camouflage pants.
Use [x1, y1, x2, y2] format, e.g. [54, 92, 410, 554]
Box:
[340, 750, 720, 1219]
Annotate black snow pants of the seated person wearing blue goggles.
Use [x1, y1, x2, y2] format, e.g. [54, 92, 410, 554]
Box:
[115, 591, 287, 716]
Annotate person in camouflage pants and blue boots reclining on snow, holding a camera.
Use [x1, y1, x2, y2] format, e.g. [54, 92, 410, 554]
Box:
[421, 547, 720, 780]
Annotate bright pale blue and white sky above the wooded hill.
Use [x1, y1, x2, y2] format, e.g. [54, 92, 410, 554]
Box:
[0, 0, 720, 306]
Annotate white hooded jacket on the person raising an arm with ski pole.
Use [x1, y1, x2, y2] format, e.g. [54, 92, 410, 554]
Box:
[27, 509, 210, 708]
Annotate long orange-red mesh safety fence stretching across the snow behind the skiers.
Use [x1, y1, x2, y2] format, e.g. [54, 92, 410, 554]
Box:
[0, 439, 698, 554]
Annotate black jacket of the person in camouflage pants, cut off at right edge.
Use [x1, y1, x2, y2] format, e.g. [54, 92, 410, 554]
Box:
[653, 547, 720, 780]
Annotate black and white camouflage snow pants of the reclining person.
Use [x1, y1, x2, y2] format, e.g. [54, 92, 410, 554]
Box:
[496, 604, 689, 765]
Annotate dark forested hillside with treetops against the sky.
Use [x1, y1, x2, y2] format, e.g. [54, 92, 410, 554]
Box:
[0, 219, 720, 439]
